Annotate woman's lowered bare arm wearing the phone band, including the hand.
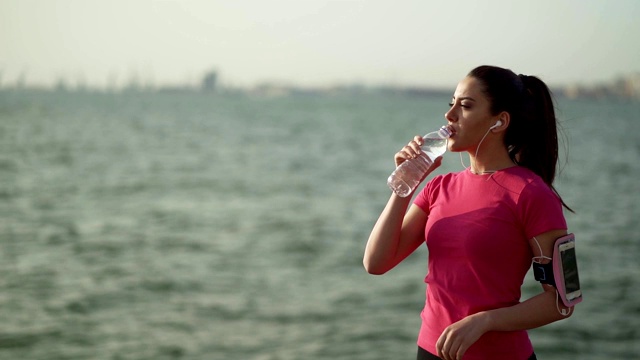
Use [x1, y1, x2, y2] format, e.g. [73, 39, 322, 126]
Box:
[436, 230, 572, 359]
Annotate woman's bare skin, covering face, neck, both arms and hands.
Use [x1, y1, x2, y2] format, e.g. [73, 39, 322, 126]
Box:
[363, 77, 572, 360]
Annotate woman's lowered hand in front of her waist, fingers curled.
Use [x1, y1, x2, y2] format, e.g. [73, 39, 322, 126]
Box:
[436, 313, 489, 360]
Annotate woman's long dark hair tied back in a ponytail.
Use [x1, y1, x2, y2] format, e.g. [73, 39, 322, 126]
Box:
[468, 65, 573, 212]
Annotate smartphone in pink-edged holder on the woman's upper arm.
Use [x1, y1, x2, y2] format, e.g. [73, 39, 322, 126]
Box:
[554, 234, 582, 307]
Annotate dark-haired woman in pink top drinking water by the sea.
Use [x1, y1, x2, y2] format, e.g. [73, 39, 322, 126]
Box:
[363, 66, 571, 360]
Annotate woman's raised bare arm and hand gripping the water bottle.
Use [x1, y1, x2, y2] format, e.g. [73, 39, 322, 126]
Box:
[362, 136, 442, 275]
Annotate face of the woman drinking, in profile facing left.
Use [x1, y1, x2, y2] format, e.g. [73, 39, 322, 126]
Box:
[445, 77, 499, 151]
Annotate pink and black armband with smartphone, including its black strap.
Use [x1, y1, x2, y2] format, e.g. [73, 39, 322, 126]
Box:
[533, 234, 582, 307]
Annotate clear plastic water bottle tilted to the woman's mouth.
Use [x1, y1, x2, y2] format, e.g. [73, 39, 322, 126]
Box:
[387, 126, 452, 197]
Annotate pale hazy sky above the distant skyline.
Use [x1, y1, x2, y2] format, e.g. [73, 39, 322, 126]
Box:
[0, 0, 640, 88]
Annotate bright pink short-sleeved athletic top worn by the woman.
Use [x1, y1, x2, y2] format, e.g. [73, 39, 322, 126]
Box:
[414, 166, 567, 360]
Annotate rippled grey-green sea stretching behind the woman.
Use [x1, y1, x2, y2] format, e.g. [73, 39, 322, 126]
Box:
[0, 89, 640, 360]
